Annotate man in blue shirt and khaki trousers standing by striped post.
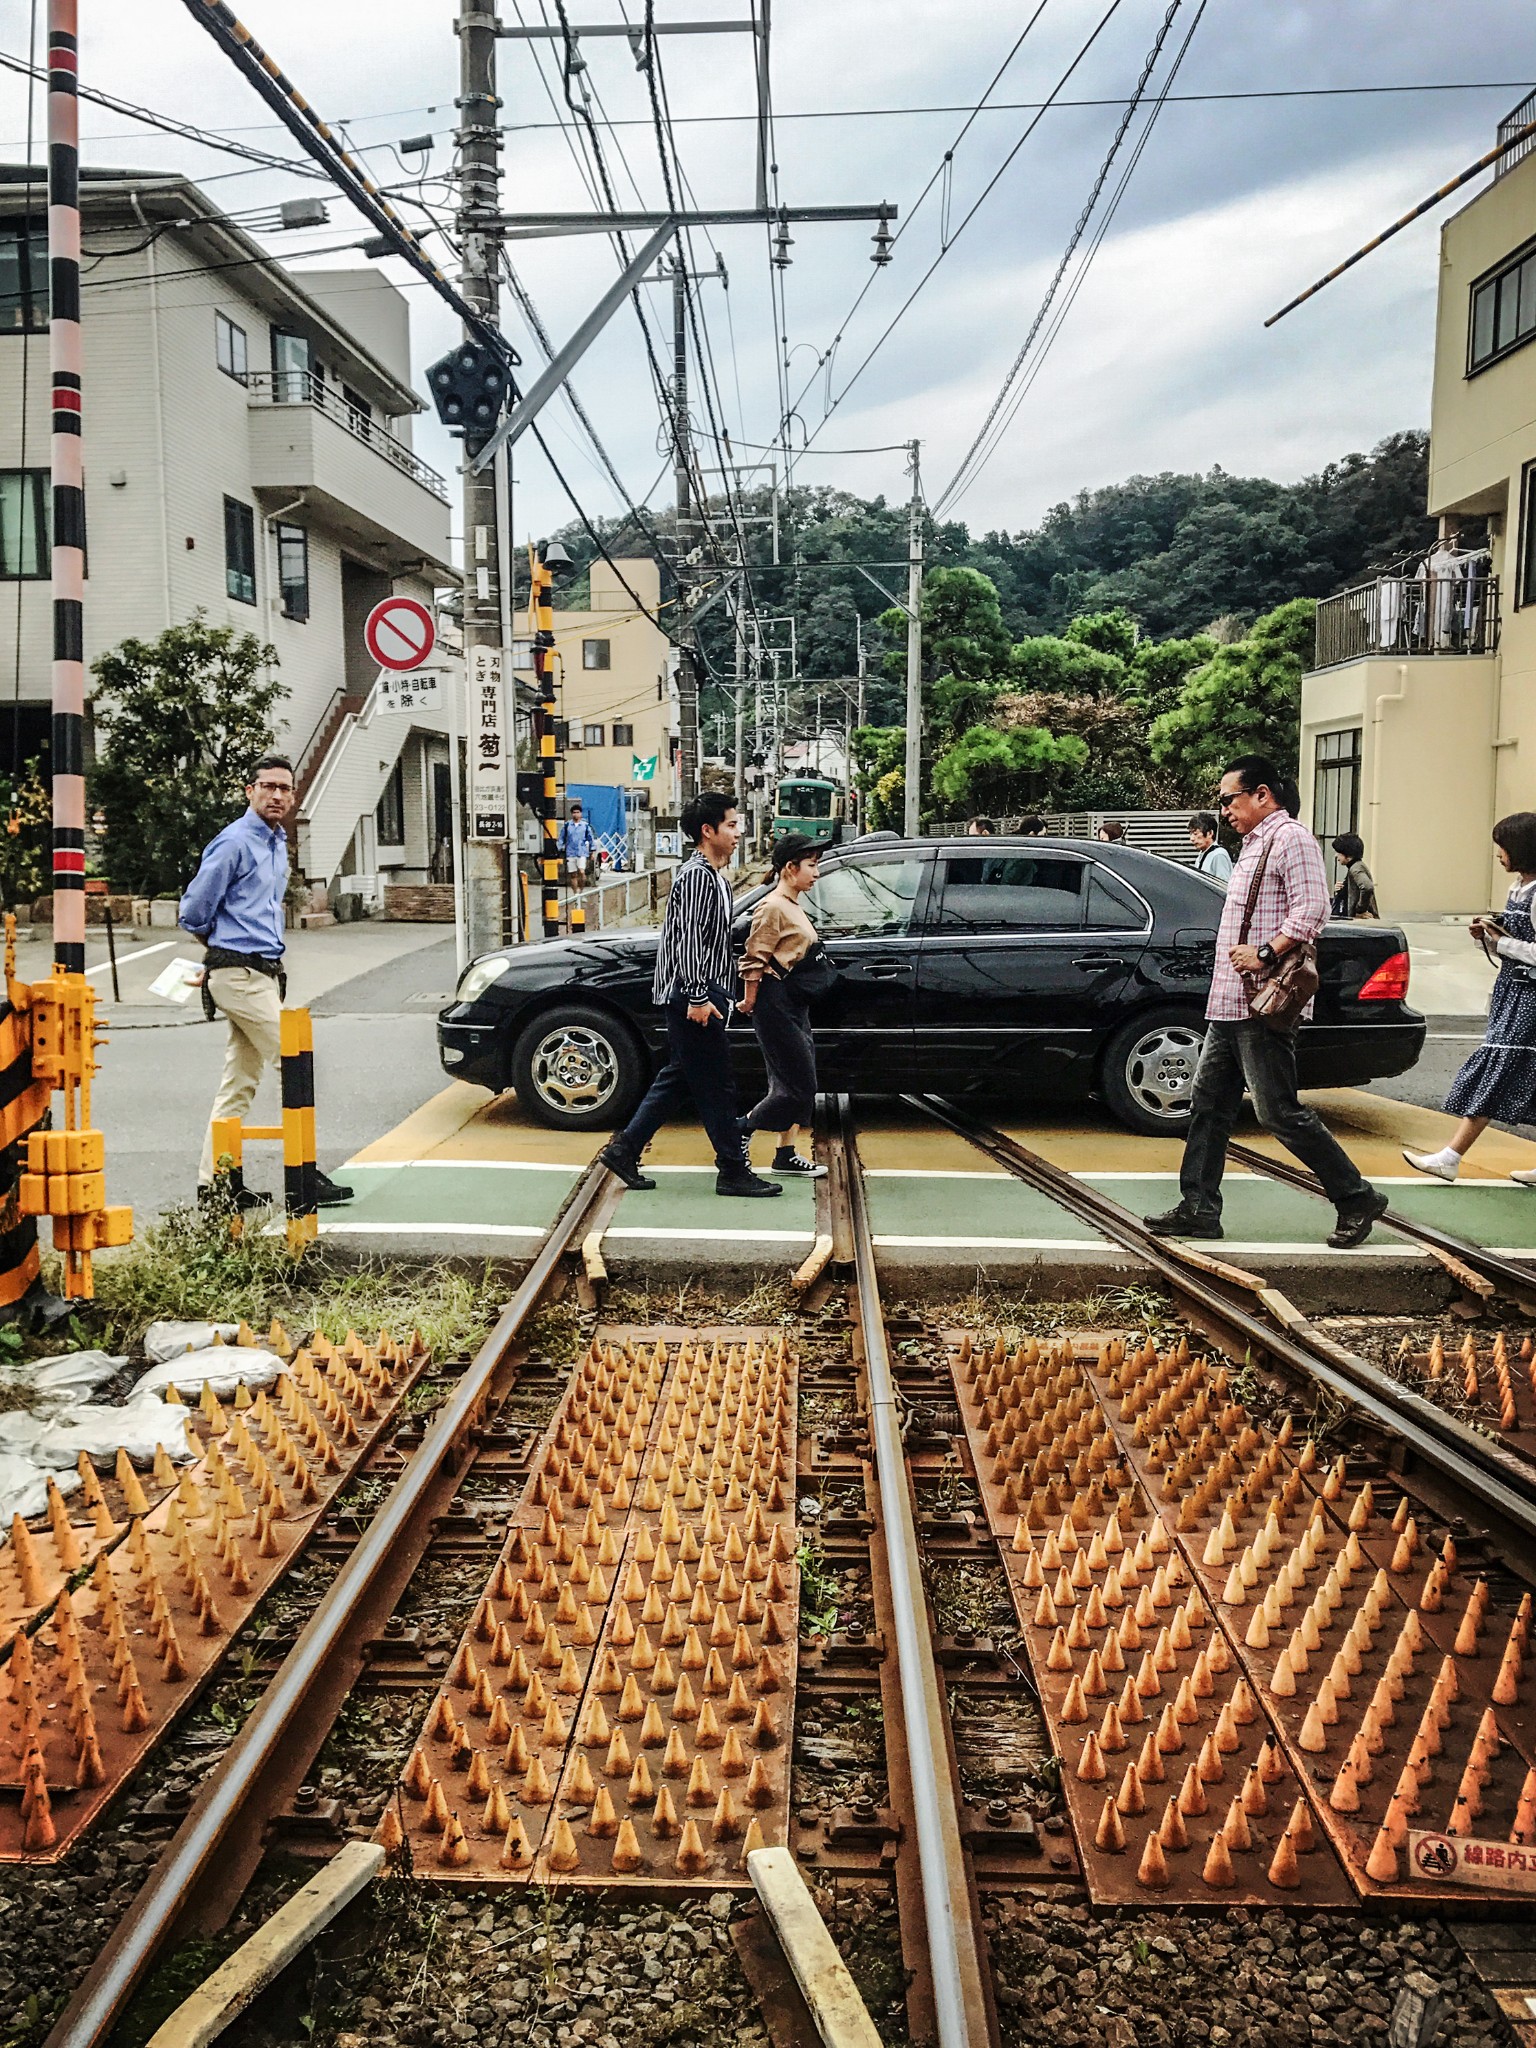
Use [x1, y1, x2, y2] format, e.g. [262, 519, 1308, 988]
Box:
[178, 754, 352, 1208]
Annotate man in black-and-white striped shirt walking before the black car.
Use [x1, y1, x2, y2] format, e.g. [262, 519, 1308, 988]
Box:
[598, 791, 784, 1196]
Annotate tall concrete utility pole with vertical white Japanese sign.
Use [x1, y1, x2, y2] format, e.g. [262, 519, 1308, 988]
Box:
[453, 0, 518, 956]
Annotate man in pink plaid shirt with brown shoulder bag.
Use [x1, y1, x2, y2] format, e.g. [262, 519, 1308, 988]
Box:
[1147, 754, 1386, 1251]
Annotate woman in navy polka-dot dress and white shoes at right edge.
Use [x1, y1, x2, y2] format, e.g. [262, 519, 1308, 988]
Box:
[1403, 811, 1536, 1188]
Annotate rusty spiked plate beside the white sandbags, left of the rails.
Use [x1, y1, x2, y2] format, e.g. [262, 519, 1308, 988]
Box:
[0, 1337, 426, 1864]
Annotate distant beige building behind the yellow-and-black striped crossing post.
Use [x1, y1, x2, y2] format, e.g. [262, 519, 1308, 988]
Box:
[512, 559, 678, 844]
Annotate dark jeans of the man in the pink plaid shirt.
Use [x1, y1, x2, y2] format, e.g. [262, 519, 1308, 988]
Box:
[1180, 1018, 1370, 1221]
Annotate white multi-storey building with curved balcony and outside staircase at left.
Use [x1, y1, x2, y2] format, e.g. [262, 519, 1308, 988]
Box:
[0, 166, 459, 895]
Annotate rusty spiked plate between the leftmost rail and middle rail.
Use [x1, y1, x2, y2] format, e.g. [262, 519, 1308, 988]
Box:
[379, 1329, 799, 1884]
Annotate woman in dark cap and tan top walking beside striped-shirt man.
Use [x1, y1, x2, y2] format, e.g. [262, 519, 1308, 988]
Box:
[741, 831, 836, 1180]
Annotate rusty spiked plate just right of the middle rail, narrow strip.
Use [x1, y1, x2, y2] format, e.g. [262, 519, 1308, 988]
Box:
[950, 1333, 1354, 1905]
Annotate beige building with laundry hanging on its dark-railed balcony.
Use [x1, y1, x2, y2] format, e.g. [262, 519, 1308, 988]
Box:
[1300, 106, 1536, 918]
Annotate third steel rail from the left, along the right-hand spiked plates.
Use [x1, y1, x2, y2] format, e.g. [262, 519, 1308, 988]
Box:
[901, 1094, 1536, 1538]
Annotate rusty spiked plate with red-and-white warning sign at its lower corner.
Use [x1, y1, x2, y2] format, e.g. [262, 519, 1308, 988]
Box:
[1085, 1348, 1536, 1898]
